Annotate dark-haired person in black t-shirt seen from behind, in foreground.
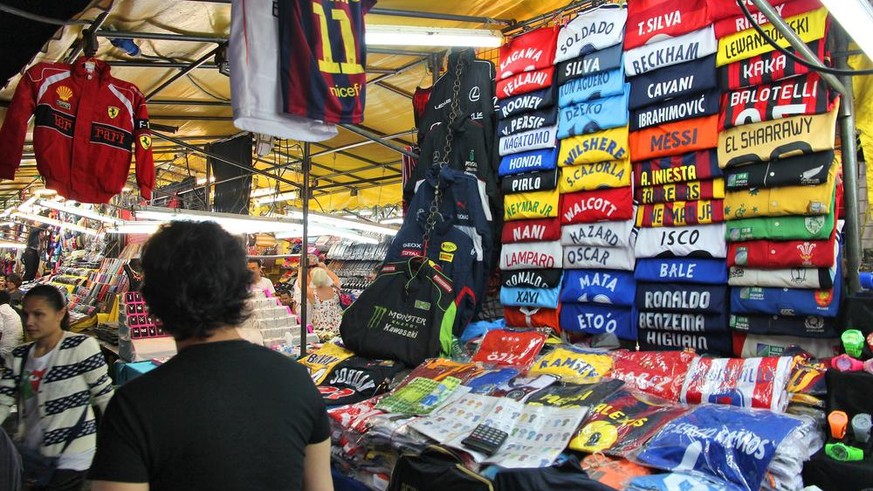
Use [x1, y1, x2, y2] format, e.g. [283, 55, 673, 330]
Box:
[89, 222, 333, 491]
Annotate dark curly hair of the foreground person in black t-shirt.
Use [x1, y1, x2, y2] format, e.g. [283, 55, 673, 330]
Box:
[142, 222, 251, 341]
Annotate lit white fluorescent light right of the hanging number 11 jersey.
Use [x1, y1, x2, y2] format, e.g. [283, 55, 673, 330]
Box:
[365, 24, 503, 48]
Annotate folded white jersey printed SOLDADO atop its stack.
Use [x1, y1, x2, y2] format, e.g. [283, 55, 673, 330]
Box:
[555, 5, 627, 64]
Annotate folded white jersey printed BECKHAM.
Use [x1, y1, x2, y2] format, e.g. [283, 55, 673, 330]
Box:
[624, 26, 718, 77]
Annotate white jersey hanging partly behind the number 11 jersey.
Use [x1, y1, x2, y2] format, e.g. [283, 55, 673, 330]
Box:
[227, 0, 338, 142]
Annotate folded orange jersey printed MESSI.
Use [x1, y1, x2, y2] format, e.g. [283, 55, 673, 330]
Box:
[629, 114, 718, 161]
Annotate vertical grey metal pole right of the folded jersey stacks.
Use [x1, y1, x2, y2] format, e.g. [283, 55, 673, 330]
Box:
[831, 25, 862, 295]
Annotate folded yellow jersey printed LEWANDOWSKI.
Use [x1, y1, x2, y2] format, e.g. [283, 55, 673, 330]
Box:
[715, 7, 828, 66]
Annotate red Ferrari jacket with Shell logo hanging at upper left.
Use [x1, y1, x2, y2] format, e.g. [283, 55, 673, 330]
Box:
[0, 58, 155, 203]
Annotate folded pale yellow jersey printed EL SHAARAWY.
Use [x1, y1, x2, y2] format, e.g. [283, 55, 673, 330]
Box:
[718, 103, 839, 168]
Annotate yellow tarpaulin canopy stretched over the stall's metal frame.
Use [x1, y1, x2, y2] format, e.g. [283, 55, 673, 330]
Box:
[0, 0, 589, 212]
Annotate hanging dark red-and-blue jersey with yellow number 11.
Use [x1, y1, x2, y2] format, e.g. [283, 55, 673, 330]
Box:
[278, 0, 376, 123]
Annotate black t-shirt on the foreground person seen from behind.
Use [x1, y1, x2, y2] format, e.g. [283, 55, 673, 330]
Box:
[89, 341, 330, 491]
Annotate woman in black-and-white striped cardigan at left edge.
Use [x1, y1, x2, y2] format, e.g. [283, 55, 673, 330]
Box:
[0, 285, 112, 491]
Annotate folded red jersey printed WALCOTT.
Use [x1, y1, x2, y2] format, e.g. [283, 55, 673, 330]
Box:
[560, 186, 633, 225]
